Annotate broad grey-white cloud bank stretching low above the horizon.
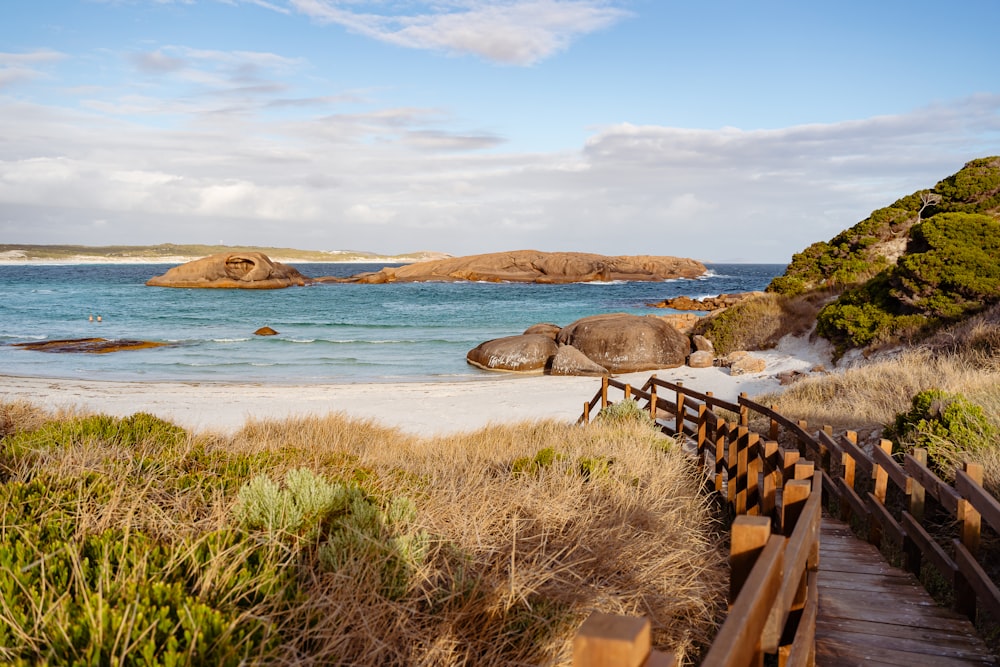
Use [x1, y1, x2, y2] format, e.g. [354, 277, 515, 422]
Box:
[0, 78, 1000, 262]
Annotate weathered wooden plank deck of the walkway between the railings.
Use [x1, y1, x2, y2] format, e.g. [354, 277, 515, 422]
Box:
[816, 517, 1000, 667]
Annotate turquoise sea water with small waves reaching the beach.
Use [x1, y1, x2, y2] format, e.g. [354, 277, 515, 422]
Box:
[0, 264, 784, 383]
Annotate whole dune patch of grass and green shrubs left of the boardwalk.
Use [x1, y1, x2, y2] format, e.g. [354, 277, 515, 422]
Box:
[0, 404, 727, 665]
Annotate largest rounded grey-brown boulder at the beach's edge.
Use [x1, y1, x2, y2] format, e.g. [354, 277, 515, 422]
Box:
[557, 313, 691, 373]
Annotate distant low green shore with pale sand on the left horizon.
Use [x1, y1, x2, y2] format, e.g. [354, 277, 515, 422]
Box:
[0, 243, 450, 263]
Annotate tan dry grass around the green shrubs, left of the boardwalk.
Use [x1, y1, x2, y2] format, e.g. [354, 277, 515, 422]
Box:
[0, 405, 727, 665]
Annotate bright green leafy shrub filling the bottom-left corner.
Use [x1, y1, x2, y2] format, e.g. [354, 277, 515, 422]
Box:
[0, 475, 295, 667]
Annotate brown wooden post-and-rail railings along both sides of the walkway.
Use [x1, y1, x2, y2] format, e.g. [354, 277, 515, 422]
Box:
[574, 376, 1000, 667]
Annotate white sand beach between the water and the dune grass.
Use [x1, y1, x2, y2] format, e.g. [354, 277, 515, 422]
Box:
[0, 341, 829, 435]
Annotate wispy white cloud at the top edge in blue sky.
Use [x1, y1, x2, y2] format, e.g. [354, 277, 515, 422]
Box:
[289, 0, 631, 66]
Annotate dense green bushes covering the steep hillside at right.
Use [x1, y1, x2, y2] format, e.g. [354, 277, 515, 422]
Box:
[767, 157, 1000, 354]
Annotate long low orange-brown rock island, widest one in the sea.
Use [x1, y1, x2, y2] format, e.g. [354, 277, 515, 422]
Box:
[328, 250, 706, 284]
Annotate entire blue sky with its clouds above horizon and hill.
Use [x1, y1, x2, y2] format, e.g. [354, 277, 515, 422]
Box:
[0, 0, 1000, 263]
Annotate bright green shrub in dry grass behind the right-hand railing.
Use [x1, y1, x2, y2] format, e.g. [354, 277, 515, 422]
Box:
[886, 389, 997, 476]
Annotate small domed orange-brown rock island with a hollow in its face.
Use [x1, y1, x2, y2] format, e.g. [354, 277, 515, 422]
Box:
[146, 252, 311, 289]
